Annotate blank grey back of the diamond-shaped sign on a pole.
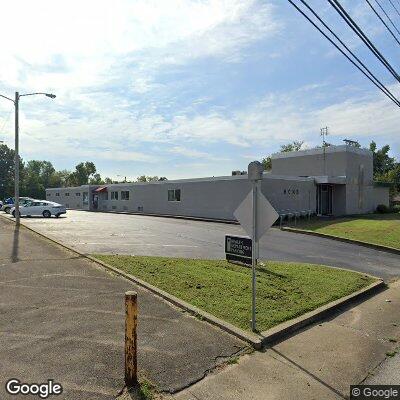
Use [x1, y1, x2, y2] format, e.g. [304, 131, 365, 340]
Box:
[233, 190, 279, 241]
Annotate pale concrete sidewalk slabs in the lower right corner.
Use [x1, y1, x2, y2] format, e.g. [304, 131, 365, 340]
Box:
[174, 281, 400, 400]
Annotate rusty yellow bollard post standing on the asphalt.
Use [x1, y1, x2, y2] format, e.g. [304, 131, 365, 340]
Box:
[125, 292, 137, 387]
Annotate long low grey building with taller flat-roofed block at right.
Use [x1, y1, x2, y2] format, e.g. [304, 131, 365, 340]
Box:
[46, 145, 389, 220]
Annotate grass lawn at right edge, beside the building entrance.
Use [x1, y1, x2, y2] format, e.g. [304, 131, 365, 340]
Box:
[297, 213, 400, 249]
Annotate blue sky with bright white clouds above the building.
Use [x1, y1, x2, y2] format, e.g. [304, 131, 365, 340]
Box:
[0, 0, 400, 179]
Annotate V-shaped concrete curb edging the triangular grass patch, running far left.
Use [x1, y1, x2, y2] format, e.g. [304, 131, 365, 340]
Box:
[0, 214, 386, 350]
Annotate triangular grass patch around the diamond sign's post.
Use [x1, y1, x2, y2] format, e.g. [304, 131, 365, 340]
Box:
[95, 255, 373, 331]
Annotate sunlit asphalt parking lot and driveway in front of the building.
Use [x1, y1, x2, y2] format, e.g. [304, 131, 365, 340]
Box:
[3, 210, 400, 280]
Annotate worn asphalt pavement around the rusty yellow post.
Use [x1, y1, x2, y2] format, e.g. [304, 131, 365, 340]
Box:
[0, 218, 245, 400]
